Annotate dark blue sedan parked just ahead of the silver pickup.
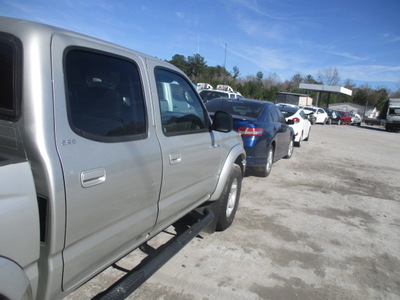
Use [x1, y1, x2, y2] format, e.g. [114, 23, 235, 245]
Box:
[205, 98, 294, 177]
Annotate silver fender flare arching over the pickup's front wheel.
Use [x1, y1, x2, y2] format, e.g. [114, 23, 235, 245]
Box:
[209, 144, 246, 201]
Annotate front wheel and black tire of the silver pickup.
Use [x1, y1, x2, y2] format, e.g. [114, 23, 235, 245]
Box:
[216, 164, 243, 231]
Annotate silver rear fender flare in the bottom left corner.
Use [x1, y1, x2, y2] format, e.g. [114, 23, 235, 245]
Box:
[0, 256, 33, 300]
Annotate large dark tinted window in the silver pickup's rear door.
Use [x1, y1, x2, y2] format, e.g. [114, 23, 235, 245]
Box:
[65, 50, 147, 142]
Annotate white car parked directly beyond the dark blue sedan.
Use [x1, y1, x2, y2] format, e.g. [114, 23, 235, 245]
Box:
[276, 103, 311, 147]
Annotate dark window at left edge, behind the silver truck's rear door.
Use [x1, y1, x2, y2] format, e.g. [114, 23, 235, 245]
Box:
[0, 33, 22, 120]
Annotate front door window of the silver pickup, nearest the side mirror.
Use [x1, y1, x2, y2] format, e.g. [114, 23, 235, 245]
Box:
[155, 69, 207, 136]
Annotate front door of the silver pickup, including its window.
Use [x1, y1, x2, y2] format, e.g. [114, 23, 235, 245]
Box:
[148, 62, 221, 228]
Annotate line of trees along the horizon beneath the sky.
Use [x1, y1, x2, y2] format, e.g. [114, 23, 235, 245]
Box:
[168, 54, 400, 110]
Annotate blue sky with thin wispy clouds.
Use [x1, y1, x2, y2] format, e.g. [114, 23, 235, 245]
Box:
[0, 0, 400, 91]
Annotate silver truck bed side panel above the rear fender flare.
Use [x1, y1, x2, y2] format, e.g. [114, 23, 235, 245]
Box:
[0, 158, 39, 296]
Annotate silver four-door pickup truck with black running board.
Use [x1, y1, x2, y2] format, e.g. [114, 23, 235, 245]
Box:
[0, 18, 246, 300]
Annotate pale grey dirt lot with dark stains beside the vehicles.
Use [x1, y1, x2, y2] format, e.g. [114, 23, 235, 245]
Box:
[68, 125, 400, 300]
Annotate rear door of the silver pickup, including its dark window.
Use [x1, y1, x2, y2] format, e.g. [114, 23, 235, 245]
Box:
[52, 36, 162, 288]
